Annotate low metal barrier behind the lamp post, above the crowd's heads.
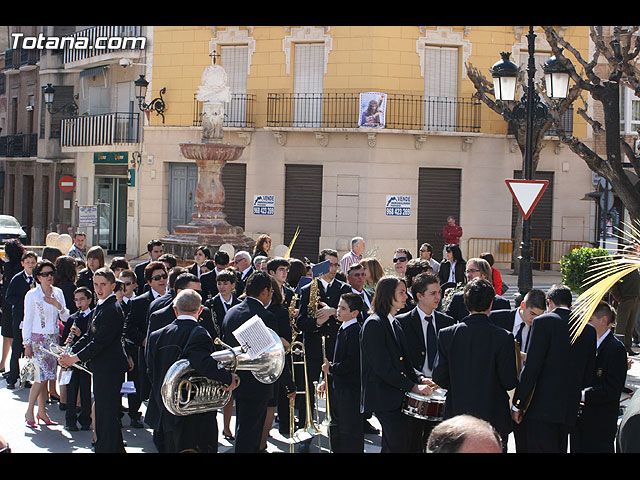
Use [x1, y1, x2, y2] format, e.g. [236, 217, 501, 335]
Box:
[467, 237, 595, 270]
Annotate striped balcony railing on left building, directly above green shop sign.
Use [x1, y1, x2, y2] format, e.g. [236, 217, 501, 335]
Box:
[60, 112, 140, 147]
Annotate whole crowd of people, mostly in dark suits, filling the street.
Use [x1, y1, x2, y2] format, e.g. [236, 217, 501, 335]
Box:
[0, 219, 640, 453]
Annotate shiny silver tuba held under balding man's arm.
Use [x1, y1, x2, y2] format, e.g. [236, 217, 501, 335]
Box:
[160, 328, 285, 417]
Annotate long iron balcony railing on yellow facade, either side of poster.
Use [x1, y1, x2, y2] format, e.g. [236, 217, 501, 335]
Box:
[267, 93, 481, 132]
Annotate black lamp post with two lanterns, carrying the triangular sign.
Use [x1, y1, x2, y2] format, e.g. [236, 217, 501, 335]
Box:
[490, 26, 569, 297]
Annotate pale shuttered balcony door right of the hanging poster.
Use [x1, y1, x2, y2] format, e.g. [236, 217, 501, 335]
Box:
[424, 46, 458, 132]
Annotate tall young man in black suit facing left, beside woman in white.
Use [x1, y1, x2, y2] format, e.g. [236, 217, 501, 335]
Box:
[58, 268, 129, 453]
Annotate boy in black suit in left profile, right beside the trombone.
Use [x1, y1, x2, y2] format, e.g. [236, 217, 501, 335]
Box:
[322, 293, 364, 453]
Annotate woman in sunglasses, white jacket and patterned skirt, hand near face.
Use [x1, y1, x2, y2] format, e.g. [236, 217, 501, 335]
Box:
[22, 260, 69, 428]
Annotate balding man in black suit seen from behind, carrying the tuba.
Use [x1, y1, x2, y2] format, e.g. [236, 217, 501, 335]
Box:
[146, 288, 237, 453]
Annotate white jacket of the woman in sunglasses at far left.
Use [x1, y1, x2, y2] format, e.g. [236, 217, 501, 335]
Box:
[22, 285, 69, 346]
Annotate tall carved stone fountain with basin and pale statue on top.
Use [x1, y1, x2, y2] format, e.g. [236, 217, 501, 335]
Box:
[161, 57, 254, 259]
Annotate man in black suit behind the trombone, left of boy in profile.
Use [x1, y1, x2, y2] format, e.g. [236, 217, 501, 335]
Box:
[296, 249, 351, 444]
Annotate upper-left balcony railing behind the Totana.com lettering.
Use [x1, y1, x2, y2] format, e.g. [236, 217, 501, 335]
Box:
[62, 25, 144, 64]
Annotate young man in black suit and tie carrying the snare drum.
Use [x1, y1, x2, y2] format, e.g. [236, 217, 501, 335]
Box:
[396, 273, 454, 453]
